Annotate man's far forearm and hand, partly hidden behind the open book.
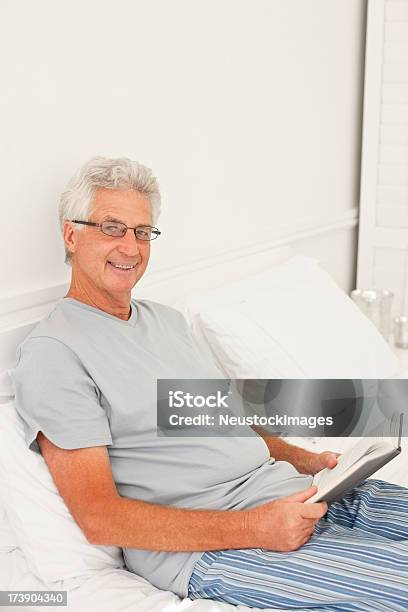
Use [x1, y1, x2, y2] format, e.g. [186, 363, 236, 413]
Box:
[252, 426, 338, 475]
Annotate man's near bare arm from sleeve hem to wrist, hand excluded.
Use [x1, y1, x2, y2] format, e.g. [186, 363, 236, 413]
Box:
[38, 433, 245, 551]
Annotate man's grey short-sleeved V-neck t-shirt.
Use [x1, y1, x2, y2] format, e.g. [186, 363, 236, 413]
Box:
[12, 298, 312, 597]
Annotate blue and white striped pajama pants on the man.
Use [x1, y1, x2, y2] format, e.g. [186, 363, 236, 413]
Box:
[188, 480, 408, 612]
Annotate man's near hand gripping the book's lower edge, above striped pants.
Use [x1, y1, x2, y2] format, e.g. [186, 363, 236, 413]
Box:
[247, 486, 327, 552]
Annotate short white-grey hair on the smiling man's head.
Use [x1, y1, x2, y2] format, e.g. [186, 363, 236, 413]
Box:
[58, 157, 161, 266]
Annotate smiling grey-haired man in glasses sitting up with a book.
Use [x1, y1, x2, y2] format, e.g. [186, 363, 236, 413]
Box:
[13, 158, 408, 612]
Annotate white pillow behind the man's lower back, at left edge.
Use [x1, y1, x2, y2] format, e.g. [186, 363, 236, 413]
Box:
[0, 400, 124, 582]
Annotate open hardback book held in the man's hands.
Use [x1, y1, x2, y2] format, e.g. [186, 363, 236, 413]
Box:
[306, 414, 403, 503]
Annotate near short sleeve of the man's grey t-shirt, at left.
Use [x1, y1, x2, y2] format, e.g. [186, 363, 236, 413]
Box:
[10, 337, 112, 452]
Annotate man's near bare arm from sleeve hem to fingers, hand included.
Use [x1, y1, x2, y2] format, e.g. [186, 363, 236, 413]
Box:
[37, 433, 327, 552]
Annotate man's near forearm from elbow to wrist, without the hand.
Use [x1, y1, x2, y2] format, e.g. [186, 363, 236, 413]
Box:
[84, 496, 254, 552]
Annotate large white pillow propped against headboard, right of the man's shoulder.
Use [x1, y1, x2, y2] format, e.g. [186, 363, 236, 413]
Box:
[184, 256, 399, 378]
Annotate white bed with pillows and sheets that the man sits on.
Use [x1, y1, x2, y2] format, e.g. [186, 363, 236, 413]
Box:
[0, 249, 408, 612]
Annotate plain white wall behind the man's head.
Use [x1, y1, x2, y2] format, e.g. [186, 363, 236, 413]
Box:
[0, 0, 365, 298]
